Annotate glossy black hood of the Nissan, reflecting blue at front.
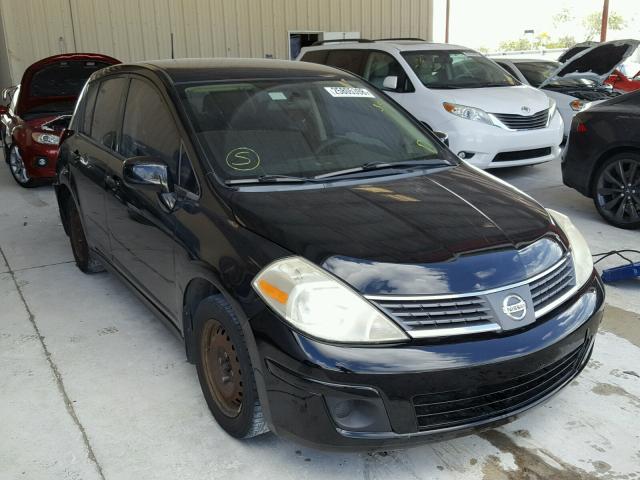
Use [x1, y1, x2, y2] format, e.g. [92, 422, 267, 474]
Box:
[231, 164, 566, 294]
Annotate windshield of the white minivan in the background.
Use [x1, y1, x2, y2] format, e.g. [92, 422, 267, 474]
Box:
[402, 50, 520, 88]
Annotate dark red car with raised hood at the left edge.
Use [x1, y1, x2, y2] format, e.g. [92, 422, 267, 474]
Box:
[0, 53, 120, 187]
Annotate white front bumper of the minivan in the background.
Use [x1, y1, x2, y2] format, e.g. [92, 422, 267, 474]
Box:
[439, 113, 564, 168]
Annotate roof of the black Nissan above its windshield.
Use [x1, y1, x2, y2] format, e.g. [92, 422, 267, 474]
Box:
[99, 58, 353, 84]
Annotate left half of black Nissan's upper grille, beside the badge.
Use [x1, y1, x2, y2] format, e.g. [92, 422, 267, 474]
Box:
[375, 297, 496, 333]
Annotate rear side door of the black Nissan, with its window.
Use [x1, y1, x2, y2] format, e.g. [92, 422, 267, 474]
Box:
[69, 77, 129, 258]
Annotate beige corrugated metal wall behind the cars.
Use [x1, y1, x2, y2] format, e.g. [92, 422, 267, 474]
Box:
[0, 0, 433, 86]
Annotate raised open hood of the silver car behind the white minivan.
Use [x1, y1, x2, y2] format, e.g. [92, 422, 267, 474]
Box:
[540, 39, 640, 88]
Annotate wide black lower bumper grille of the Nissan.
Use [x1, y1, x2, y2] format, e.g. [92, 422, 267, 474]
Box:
[413, 342, 590, 431]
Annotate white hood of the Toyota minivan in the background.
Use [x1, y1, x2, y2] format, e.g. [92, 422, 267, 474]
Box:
[431, 85, 549, 115]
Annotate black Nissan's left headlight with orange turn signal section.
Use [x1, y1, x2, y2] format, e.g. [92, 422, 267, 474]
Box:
[252, 257, 408, 343]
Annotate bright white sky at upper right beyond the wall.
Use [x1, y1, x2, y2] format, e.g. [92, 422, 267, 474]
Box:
[433, 0, 640, 51]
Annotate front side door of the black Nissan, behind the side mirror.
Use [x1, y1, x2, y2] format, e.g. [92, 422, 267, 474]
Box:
[106, 76, 181, 318]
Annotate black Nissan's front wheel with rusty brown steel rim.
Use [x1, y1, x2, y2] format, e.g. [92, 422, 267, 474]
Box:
[194, 295, 269, 438]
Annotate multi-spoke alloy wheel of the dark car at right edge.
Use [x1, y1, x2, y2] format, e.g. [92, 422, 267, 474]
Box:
[593, 152, 640, 229]
